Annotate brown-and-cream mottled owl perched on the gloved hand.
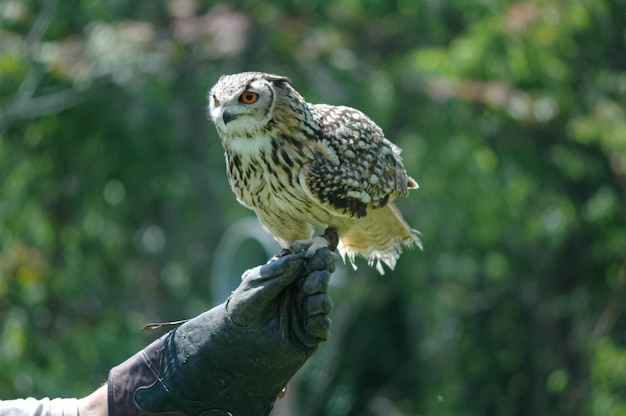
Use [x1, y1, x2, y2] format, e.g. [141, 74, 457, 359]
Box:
[208, 72, 421, 274]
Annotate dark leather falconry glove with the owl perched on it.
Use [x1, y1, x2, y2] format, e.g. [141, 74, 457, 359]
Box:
[108, 249, 335, 416]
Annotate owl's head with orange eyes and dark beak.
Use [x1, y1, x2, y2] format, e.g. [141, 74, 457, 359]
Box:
[209, 72, 291, 136]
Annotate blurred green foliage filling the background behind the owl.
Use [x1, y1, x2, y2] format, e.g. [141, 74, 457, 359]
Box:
[0, 0, 626, 416]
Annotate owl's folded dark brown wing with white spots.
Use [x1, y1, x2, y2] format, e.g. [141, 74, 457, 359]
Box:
[300, 104, 414, 217]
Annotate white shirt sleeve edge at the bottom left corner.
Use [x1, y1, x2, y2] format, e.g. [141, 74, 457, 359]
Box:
[0, 397, 78, 416]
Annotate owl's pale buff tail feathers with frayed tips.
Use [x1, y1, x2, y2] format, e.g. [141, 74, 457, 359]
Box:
[337, 203, 422, 274]
